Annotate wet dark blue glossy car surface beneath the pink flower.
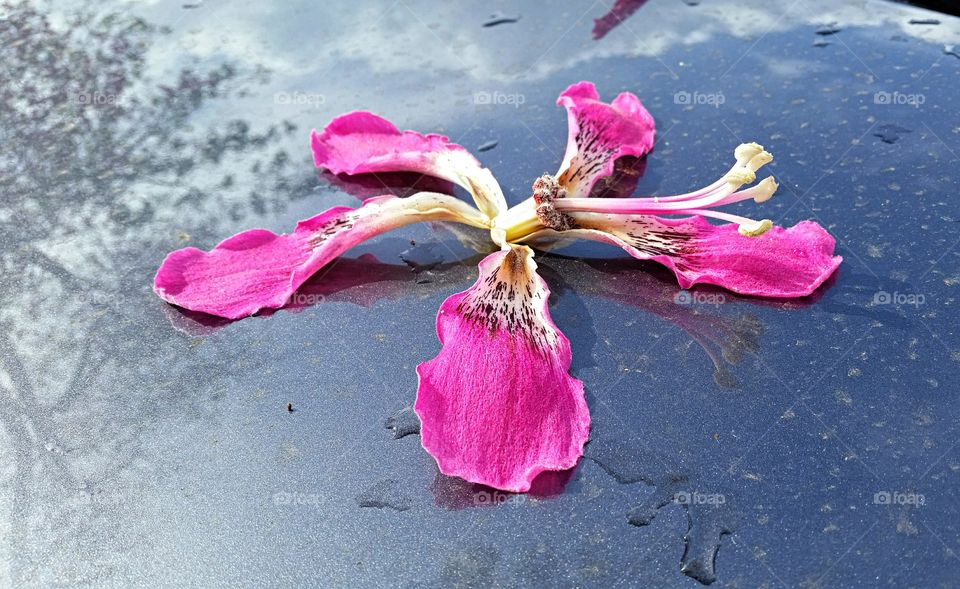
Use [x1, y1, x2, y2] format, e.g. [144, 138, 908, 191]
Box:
[0, 0, 960, 587]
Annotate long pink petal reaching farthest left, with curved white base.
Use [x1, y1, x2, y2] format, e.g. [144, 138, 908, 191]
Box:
[153, 192, 487, 319]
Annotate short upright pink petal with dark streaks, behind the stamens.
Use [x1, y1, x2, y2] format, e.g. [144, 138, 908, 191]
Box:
[557, 82, 656, 197]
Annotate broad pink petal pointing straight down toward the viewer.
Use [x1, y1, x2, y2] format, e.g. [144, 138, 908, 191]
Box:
[414, 246, 590, 492]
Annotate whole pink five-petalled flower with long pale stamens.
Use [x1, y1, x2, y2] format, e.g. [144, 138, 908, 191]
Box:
[154, 82, 841, 492]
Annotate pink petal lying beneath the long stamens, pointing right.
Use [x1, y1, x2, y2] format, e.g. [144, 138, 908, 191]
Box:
[527, 213, 843, 297]
